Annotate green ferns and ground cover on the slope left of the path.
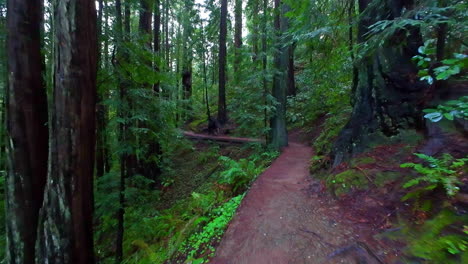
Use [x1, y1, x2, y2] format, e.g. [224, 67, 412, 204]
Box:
[95, 142, 278, 264]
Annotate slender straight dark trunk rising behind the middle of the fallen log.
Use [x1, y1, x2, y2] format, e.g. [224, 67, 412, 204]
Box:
[218, 0, 228, 125]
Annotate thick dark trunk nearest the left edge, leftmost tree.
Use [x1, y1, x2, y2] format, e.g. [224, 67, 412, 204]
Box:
[6, 0, 48, 264]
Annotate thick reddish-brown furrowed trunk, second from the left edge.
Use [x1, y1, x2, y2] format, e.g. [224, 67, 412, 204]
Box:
[37, 0, 98, 264]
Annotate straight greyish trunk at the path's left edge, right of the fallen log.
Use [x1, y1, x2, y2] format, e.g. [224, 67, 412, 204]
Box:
[270, 0, 289, 149]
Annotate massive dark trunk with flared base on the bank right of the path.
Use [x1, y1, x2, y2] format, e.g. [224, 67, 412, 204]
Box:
[332, 0, 430, 166]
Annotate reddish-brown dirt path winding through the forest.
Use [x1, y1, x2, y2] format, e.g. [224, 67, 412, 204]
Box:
[210, 137, 390, 264]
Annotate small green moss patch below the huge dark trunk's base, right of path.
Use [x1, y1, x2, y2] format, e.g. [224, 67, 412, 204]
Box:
[327, 169, 369, 196]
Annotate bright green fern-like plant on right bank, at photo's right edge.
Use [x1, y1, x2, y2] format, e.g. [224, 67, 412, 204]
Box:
[401, 153, 468, 200]
